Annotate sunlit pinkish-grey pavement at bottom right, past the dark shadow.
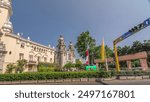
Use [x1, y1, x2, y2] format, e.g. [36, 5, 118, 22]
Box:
[103, 79, 150, 85]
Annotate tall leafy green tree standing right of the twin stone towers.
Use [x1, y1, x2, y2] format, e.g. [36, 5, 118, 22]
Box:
[75, 31, 96, 58]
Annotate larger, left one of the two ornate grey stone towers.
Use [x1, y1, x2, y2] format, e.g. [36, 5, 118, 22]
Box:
[57, 35, 67, 68]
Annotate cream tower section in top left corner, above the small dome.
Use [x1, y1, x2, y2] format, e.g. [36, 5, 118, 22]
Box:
[0, 0, 12, 32]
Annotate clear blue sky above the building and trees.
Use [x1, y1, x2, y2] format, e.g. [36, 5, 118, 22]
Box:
[11, 0, 150, 47]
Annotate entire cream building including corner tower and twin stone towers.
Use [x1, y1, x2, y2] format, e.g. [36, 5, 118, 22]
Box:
[0, 0, 75, 73]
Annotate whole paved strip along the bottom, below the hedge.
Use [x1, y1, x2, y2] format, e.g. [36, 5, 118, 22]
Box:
[3, 79, 150, 85]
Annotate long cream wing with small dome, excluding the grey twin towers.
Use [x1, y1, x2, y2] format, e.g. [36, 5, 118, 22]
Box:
[0, 22, 55, 73]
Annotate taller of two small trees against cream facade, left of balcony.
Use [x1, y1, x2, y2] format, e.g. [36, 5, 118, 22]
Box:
[16, 59, 27, 73]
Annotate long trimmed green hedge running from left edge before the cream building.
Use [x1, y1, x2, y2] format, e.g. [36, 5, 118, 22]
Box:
[0, 71, 112, 81]
